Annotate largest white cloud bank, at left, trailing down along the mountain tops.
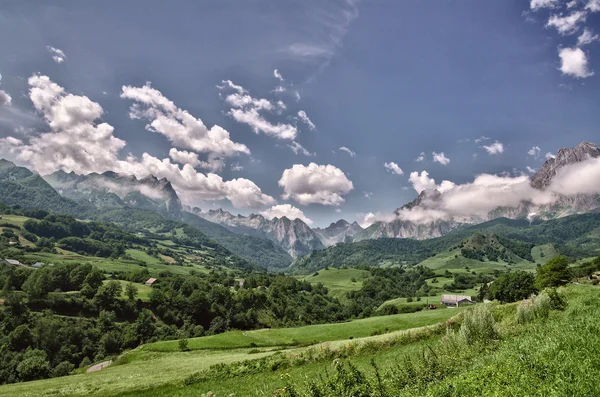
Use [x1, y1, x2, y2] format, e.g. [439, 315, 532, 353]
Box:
[0, 75, 275, 208]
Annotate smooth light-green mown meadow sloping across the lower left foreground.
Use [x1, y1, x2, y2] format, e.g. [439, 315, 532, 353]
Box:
[0, 310, 458, 397]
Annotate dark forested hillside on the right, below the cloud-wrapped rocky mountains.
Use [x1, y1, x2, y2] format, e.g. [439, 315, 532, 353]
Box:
[291, 213, 600, 274]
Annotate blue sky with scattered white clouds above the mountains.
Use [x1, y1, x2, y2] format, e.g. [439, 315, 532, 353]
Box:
[0, 0, 600, 226]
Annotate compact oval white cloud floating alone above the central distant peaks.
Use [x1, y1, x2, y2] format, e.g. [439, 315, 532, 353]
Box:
[279, 163, 354, 206]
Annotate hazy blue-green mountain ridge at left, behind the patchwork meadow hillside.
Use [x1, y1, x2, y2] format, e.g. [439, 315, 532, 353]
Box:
[0, 160, 292, 269]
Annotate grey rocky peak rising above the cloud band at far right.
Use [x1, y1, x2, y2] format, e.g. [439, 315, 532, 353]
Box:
[531, 142, 600, 190]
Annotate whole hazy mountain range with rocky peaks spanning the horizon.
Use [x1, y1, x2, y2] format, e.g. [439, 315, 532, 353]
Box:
[0, 142, 600, 269]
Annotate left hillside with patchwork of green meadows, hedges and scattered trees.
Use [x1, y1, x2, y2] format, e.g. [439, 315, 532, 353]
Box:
[0, 204, 256, 276]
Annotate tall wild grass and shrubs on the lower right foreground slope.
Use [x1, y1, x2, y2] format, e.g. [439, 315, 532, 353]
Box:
[275, 287, 588, 397]
